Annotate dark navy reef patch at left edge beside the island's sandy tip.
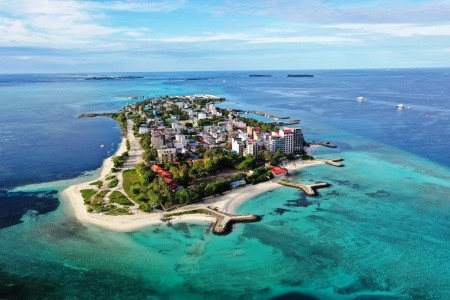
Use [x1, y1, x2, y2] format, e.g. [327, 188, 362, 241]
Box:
[0, 191, 59, 229]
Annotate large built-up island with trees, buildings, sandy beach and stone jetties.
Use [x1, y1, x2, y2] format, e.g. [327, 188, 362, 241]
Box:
[62, 95, 342, 234]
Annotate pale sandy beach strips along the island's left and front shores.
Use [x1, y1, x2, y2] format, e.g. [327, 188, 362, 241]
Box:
[59, 143, 324, 232]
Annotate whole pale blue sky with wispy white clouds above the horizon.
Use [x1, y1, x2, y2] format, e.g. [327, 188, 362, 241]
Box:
[0, 0, 450, 73]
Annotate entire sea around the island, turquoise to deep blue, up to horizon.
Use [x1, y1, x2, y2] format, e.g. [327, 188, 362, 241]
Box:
[0, 69, 450, 299]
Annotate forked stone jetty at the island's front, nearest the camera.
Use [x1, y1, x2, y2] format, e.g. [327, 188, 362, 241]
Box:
[161, 206, 261, 235]
